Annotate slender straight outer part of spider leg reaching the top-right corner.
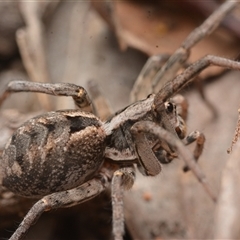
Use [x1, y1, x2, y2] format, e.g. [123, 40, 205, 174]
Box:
[152, 1, 237, 92]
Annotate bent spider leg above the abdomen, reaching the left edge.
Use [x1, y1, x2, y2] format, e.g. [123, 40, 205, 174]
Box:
[0, 81, 91, 109]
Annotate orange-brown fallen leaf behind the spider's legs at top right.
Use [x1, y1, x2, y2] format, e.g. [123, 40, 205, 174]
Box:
[92, 1, 240, 77]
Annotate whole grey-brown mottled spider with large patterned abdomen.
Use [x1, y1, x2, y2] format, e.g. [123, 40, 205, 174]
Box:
[0, 1, 240, 240]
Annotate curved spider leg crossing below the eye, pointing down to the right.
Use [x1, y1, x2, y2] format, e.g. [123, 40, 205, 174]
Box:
[131, 121, 217, 202]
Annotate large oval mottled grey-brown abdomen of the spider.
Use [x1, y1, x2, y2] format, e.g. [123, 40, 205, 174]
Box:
[0, 110, 106, 197]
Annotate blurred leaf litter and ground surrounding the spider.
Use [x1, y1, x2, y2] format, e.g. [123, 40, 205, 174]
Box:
[0, 0, 240, 240]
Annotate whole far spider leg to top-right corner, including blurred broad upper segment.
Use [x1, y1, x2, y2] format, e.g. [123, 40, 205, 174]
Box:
[131, 1, 237, 102]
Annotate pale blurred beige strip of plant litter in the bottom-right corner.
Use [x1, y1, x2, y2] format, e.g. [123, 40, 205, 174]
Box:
[214, 142, 240, 239]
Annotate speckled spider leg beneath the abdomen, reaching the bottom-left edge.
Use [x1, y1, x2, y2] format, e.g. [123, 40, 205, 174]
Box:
[10, 170, 110, 240]
